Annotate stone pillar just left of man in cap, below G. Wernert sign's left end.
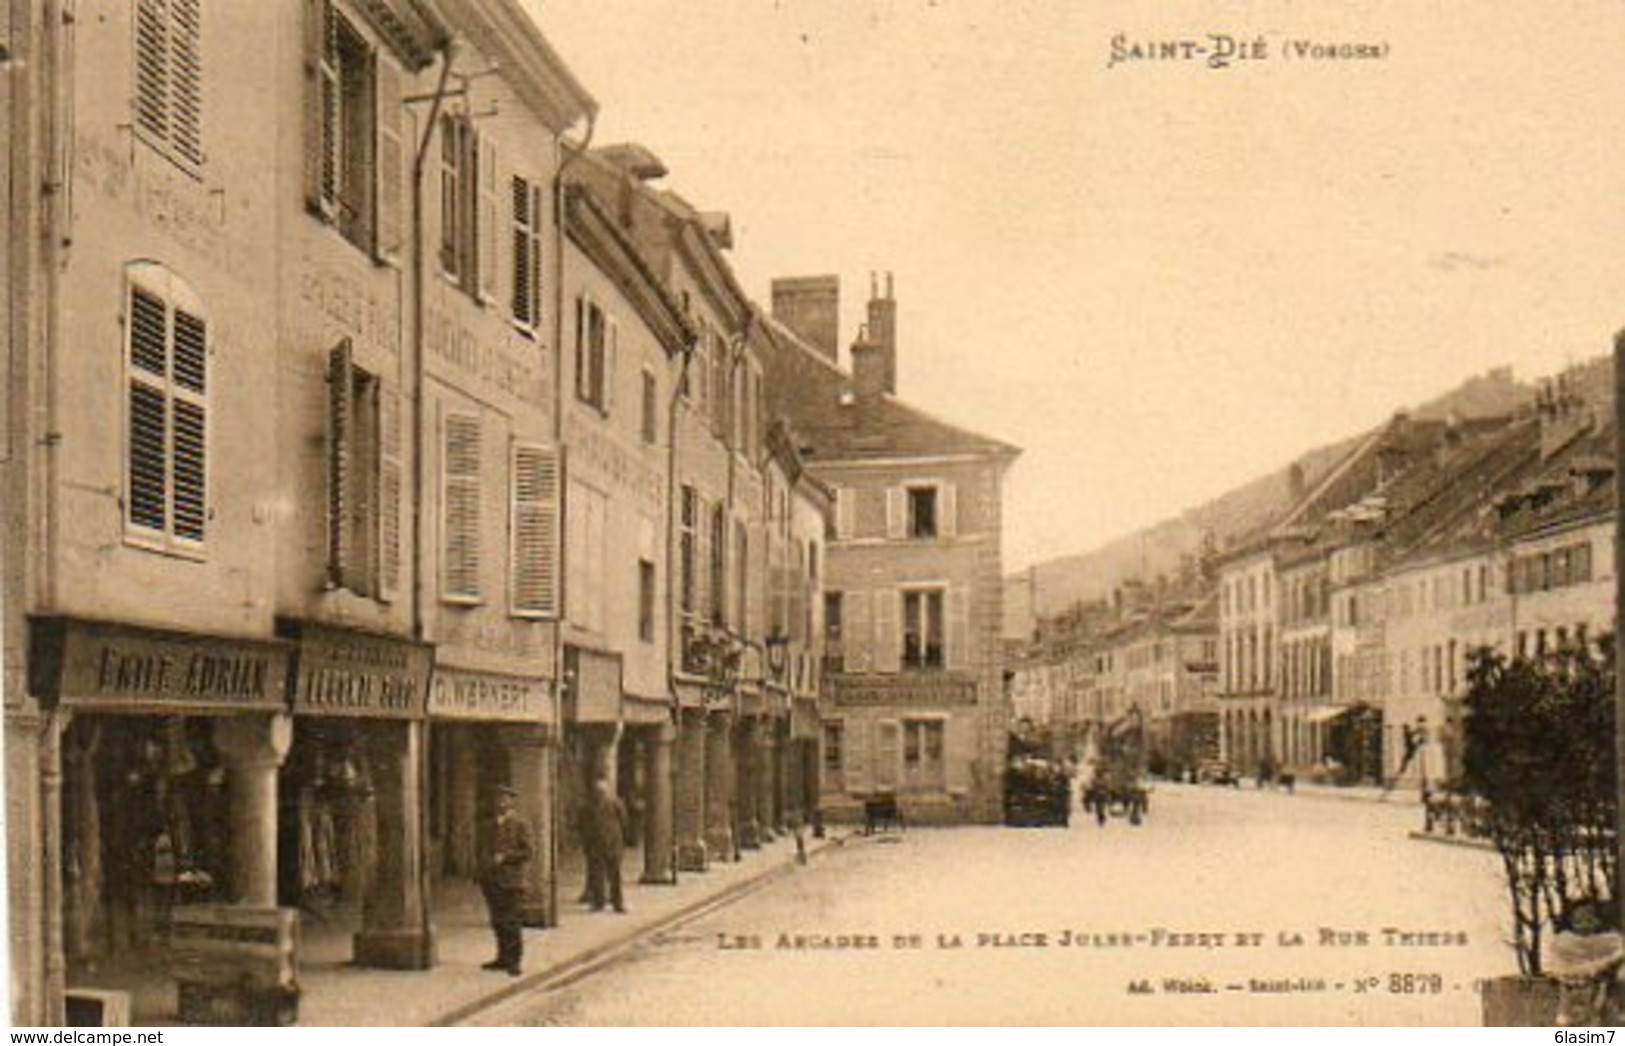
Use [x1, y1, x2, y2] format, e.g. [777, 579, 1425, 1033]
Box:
[353, 723, 434, 970]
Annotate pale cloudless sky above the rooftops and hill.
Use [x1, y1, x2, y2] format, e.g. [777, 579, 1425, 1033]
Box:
[523, 0, 1625, 570]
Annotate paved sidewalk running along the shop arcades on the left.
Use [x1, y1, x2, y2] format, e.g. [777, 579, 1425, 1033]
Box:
[299, 830, 845, 1027]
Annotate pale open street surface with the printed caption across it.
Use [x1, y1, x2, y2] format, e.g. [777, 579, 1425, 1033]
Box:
[471, 786, 1513, 1025]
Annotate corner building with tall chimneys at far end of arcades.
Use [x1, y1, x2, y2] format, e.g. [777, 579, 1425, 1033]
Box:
[767, 274, 1019, 823]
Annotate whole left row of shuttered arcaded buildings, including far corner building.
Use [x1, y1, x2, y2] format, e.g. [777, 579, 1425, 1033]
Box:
[0, 0, 1017, 1025]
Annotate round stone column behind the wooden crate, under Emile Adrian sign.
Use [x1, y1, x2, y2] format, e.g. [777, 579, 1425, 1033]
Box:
[215, 715, 294, 908]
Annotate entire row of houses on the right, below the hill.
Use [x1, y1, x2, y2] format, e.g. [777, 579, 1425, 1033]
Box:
[1011, 359, 1615, 788]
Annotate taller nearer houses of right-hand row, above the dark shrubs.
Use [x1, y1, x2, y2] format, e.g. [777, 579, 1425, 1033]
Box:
[1216, 359, 1615, 785]
